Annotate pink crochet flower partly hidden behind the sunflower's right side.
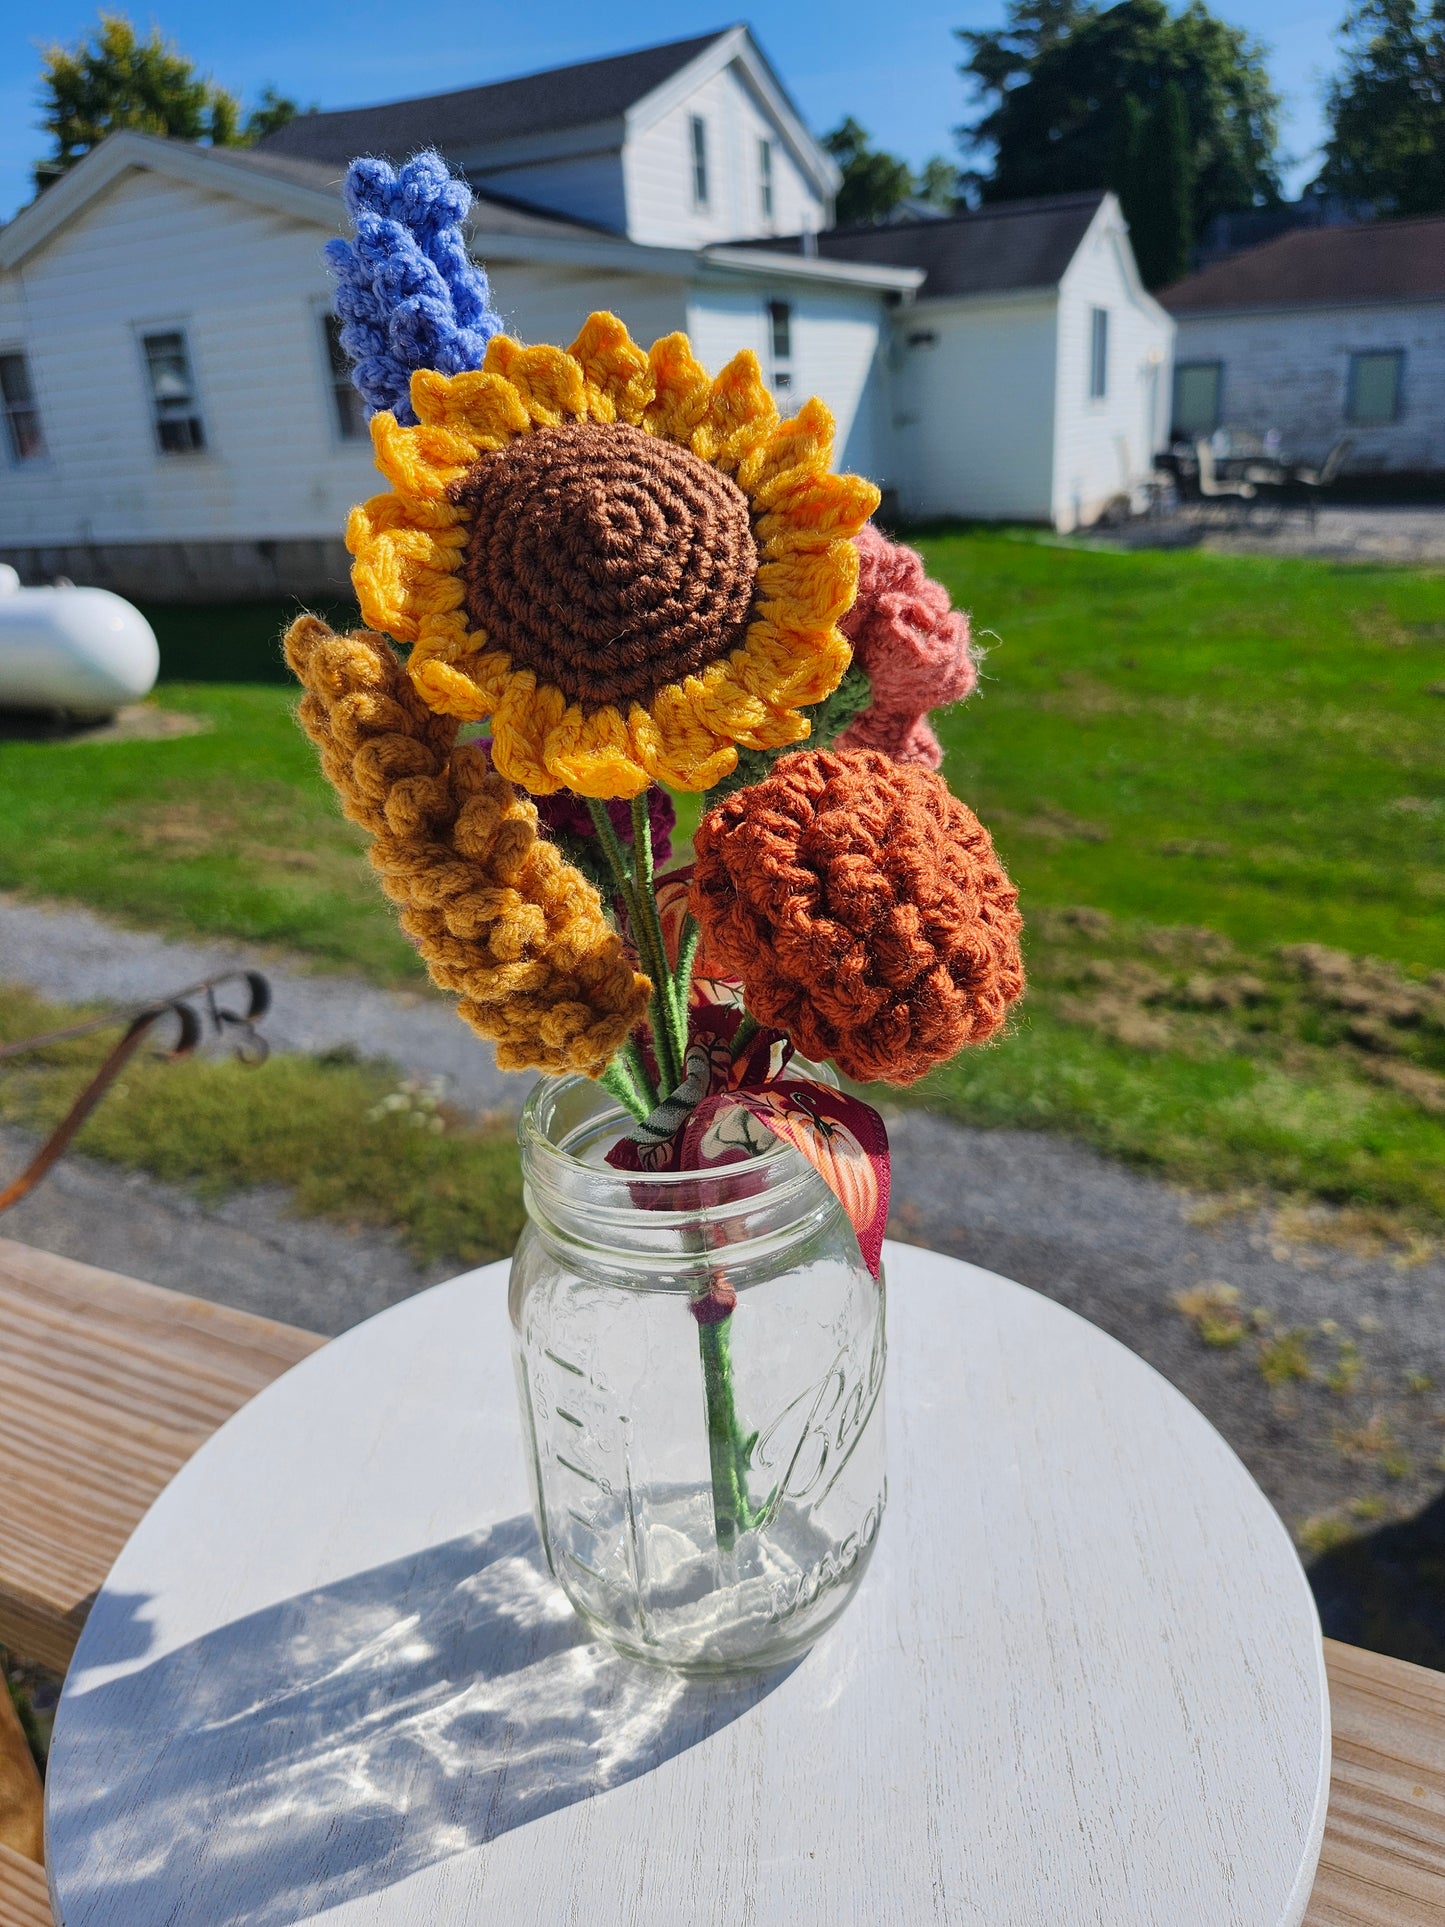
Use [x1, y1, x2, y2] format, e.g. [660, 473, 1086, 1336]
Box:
[836, 522, 979, 769]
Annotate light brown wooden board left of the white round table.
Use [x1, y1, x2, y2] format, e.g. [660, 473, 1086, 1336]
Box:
[0, 1239, 326, 1673]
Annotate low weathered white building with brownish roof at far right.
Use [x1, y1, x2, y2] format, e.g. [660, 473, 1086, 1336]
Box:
[1160, 216, 1445, 476]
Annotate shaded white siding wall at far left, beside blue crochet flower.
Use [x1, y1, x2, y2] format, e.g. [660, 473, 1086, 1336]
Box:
[0, 173, 376, 545]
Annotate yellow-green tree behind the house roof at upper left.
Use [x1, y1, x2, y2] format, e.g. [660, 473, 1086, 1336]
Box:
[35, 12, 306, 187]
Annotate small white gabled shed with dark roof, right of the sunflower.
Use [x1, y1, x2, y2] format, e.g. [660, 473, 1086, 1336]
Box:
[747, 193, 1173, 530]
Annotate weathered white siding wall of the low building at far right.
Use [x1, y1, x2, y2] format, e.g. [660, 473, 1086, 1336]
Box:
[1175, 303, 1445, 472]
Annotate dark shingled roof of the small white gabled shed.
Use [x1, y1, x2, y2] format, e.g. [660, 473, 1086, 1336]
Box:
[738, 193, 1104, 297]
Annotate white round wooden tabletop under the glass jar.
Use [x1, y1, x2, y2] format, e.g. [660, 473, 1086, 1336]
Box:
[48, 1245, 1329, 1927]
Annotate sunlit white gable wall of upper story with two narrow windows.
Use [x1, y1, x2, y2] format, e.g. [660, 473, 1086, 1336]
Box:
[622, 66, 823, 247]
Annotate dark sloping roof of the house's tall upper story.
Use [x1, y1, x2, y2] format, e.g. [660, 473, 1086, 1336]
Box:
[258, 29, 728, 166]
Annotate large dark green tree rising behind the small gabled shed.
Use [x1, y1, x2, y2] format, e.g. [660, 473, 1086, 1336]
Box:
[958, 0, 1279, 247]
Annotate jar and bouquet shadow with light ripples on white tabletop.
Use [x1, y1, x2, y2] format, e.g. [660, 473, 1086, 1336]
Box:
[50, 1518, 786, 1927]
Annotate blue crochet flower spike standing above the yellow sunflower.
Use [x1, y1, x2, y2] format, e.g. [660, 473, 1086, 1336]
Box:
[326, 152, 501, 426]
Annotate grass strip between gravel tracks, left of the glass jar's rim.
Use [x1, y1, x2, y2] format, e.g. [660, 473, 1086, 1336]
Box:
[0, 985, 522, 1264]
